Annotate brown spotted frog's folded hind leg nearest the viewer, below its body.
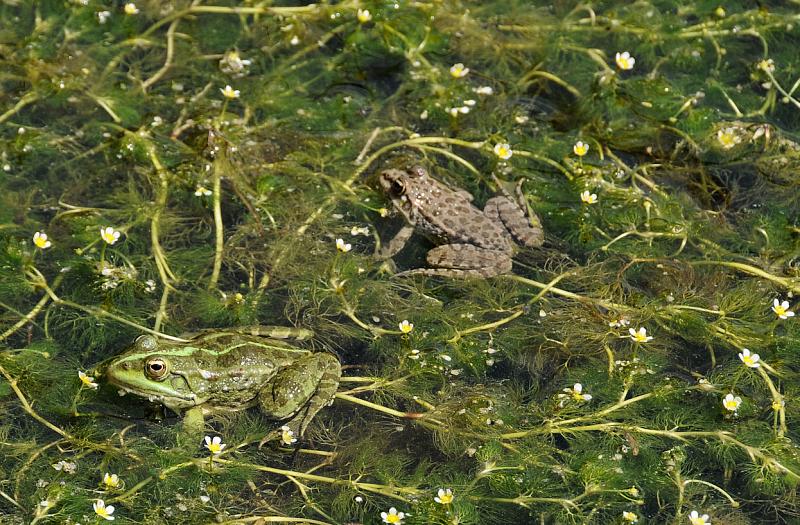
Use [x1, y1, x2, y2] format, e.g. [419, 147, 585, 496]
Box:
[397, 244, 513, 278]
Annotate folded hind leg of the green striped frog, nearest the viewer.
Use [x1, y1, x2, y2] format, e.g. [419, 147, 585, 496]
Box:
[258, 353, 342, 436]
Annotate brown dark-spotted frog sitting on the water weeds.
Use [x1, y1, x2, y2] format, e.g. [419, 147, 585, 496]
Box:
[379, 166, 544, 277]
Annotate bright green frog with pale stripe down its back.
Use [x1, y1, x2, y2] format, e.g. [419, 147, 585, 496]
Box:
[105, 327, 341, 436]
